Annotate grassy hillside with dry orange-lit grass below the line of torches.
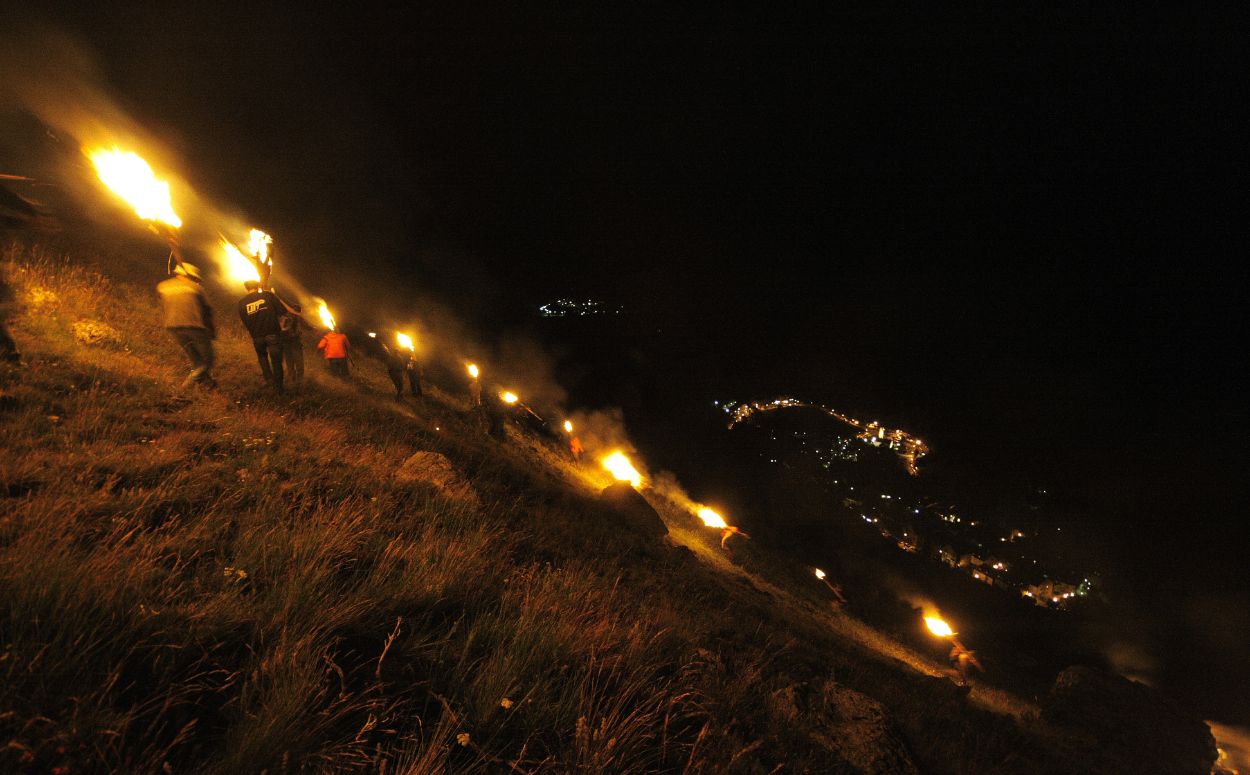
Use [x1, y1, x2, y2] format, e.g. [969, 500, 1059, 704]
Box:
[0, 238, 1185, 774]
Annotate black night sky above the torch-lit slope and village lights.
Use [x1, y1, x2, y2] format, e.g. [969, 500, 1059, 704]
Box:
[4, 4, 1248, 720]
